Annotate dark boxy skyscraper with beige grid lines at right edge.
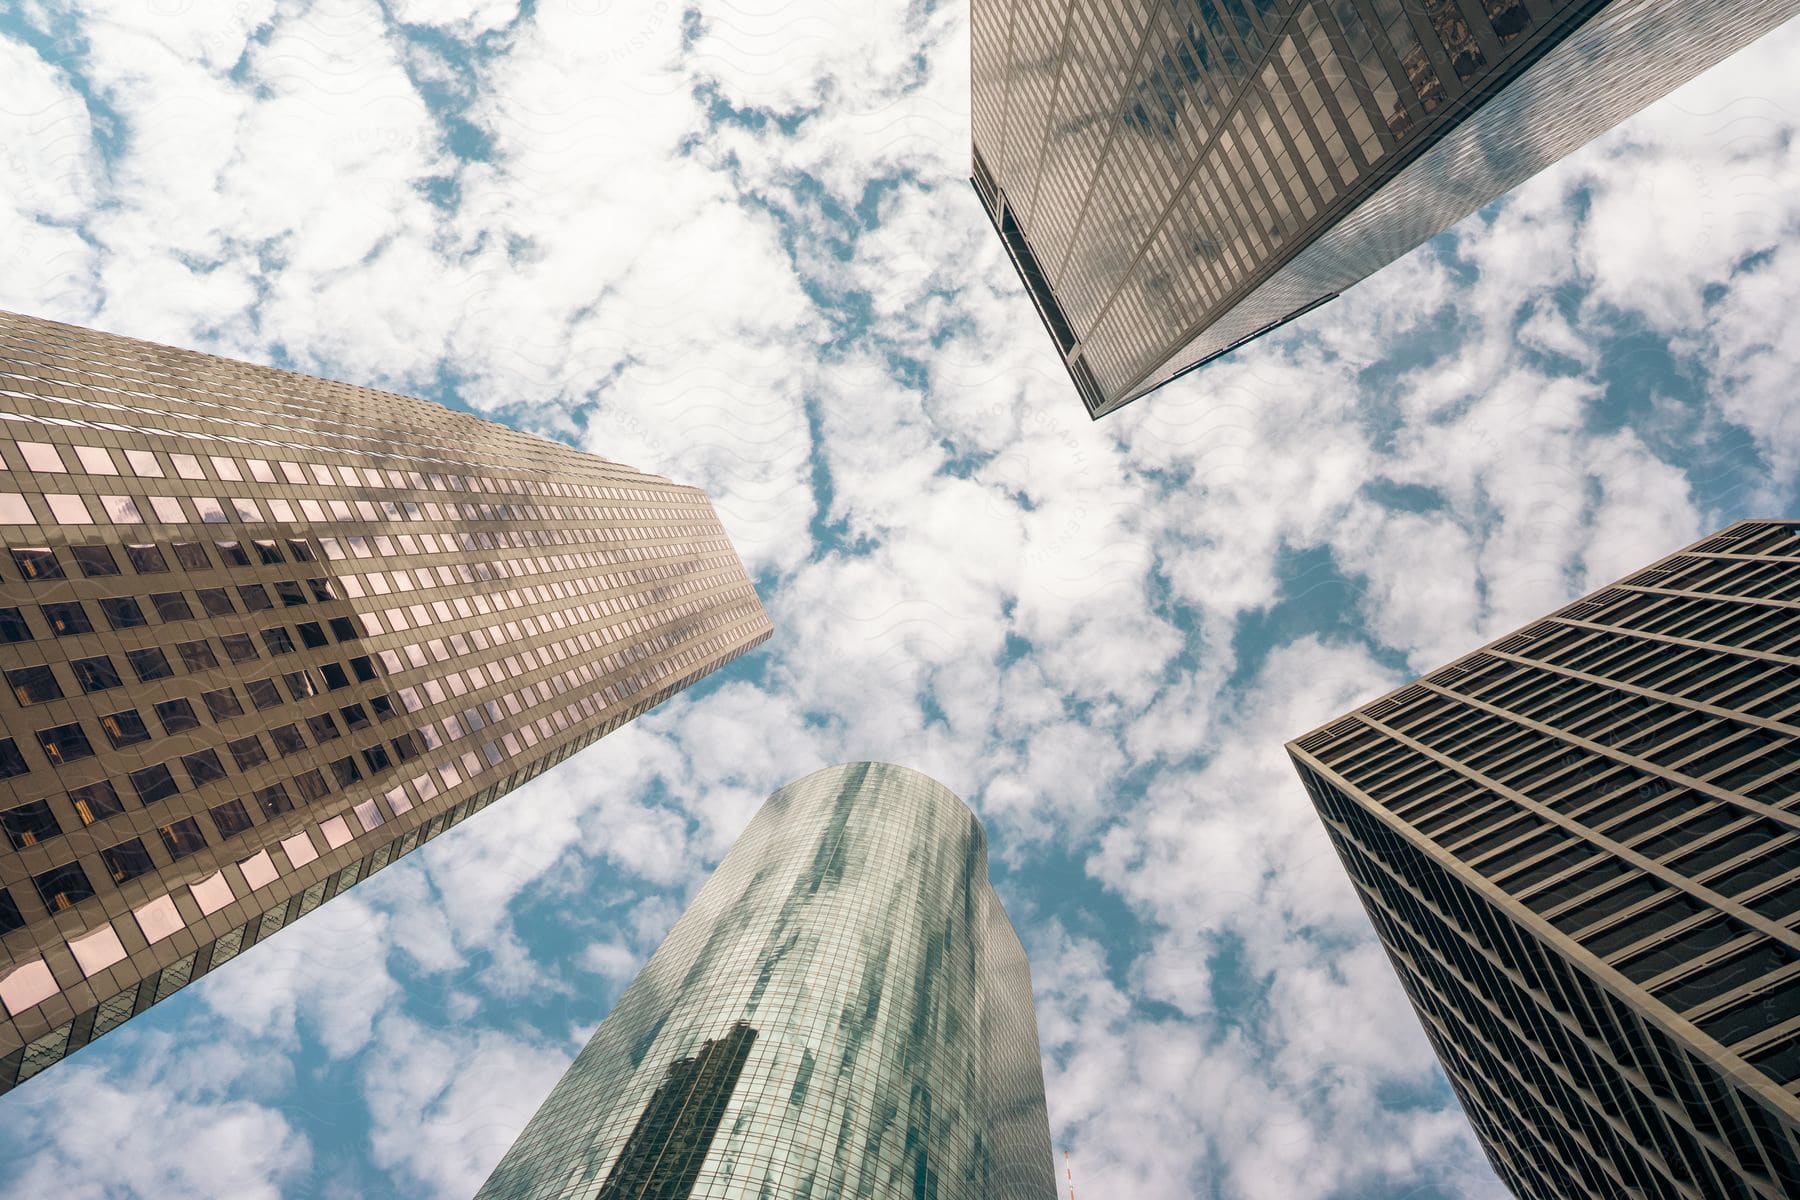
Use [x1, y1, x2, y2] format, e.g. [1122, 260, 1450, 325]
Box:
[1289, 522, 1800, 1200]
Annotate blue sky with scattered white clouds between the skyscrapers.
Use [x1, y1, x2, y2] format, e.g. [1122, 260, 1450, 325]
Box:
[0, 0, 1800, 1200]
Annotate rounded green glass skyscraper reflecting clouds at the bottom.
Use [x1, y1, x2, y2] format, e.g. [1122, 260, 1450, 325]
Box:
[479, 763, 1057, 1200]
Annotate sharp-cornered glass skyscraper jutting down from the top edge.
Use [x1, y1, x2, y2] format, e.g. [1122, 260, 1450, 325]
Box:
[970, 0, 1800, 417]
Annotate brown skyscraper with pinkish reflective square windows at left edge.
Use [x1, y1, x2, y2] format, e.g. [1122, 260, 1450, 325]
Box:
[0, 315, 770, 1090]
